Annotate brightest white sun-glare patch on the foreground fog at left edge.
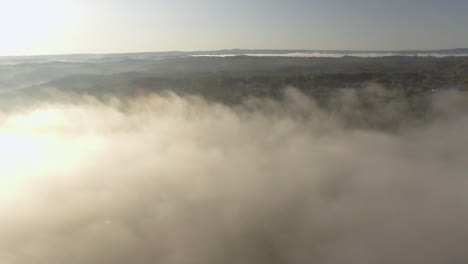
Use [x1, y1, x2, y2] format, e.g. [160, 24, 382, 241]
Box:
[0, 108, 104, 198]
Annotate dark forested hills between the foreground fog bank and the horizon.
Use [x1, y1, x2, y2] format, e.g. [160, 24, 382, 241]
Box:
[10, 56, 468, 103]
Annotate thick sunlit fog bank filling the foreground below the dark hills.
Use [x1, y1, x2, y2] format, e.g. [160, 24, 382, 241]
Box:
[0, 90, 468, 264]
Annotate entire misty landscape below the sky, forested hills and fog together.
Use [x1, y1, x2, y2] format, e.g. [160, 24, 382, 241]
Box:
[0, 52, 468, 264]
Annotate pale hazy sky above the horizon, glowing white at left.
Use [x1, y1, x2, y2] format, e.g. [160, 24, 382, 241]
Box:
[0, 0, 468, 56]
